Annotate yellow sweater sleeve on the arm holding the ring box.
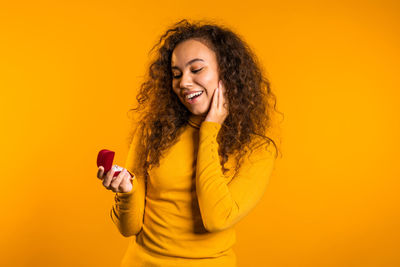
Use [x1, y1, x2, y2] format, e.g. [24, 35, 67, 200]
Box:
[110, 126, 146, 237]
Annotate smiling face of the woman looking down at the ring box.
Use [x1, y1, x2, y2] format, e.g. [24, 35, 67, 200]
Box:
[171, 39, 219, 116]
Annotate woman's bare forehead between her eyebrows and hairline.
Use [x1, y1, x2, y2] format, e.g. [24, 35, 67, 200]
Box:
[171, 39, 216, 67]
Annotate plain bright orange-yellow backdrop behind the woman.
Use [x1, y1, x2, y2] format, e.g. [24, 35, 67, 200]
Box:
[0, 0, 400, 267]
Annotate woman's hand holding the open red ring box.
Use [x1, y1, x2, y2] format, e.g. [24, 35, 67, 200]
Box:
[97, 166, 132, 193]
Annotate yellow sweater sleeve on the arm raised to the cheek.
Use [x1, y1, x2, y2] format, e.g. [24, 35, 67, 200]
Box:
[196, 121, 276, 232]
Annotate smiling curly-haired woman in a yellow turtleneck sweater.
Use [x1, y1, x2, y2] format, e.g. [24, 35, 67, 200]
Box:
[98, 20, 278, 267]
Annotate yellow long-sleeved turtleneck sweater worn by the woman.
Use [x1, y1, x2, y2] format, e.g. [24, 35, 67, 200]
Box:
[111, 115, 276, 267]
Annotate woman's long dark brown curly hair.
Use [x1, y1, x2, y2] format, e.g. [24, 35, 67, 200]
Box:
[129, 19, 279, 181]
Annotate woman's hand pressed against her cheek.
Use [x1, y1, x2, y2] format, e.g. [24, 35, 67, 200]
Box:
[204, 81, 229, 125]
